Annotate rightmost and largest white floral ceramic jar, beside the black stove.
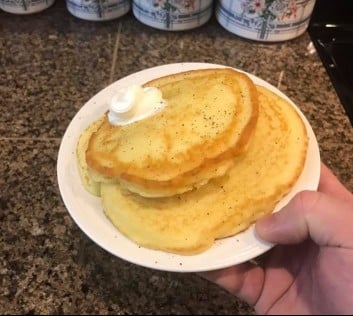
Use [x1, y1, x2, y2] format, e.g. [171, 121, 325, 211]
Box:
[216, 0, 315, 42]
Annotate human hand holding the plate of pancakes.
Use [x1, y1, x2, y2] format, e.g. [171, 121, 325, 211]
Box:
[201, 164, 353, 315]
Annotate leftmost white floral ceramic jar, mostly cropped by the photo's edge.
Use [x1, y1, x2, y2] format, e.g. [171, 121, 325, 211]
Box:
[0, 0, 55, 14]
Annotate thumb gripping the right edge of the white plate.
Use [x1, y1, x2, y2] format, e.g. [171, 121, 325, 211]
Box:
[255, 191, 353, 247]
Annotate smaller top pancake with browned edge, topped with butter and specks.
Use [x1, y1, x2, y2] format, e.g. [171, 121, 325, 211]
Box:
[86, 69, 258, 196]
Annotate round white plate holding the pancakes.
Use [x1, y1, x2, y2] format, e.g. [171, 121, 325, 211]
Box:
[57, 63, 320, 272]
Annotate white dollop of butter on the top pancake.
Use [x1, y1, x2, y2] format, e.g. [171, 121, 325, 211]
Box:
[108, 85, 167, 126]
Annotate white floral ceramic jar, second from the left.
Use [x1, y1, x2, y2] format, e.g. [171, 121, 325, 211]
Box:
[66, 0, 131, 21]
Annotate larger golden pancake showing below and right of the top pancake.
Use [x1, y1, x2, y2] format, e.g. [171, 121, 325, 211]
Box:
[101, 87, 308, 255]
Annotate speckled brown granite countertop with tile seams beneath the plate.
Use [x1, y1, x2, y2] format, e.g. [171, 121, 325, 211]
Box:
[0, 1, 353, 314]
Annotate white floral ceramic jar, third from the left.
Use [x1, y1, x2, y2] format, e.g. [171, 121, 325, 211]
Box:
[132, 0, 213, 31]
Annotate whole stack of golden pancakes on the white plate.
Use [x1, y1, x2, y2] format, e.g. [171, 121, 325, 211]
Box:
[77, 68, 308, 254]
